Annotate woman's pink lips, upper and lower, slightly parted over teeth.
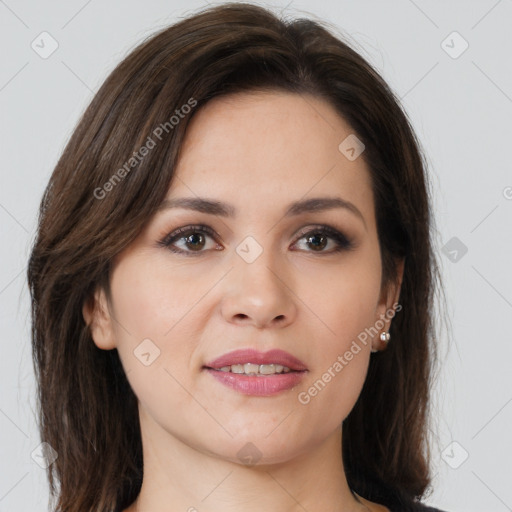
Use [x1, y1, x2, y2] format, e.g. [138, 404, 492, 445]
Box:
[205, 349, 307, 396]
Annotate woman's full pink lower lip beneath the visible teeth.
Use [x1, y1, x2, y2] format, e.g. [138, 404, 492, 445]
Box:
[206, 368, 306, 396]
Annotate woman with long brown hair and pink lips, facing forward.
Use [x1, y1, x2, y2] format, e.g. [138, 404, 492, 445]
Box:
[28, 3, 448, 512]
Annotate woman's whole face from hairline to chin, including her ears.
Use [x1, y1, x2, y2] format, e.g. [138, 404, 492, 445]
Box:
[84, 92, 404, 463]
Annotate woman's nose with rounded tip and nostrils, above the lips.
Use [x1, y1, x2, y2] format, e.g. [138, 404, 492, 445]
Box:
[221, 251, 297, 329]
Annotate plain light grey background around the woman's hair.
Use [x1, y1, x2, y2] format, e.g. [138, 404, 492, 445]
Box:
[0, 0, 512, 512]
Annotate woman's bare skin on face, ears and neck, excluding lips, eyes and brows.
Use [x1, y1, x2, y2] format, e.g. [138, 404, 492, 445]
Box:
[83, 92, 403, 512]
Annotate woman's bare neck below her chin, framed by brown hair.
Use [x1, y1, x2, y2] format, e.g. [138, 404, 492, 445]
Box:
[125, 407, 369, 512]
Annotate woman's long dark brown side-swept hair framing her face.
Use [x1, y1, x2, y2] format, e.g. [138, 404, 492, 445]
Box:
[28, 3, 446, 512]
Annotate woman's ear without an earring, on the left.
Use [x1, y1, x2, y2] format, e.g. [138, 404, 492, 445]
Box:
[82, 287, 116, 350]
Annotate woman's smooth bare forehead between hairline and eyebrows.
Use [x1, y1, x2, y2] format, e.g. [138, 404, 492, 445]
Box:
[168, 91, 373, 225]
